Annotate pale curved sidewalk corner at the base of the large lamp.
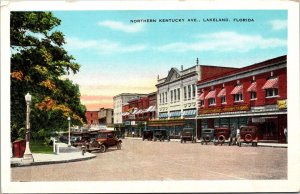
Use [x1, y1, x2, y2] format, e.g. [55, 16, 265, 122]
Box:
[10, 143, 96, 167]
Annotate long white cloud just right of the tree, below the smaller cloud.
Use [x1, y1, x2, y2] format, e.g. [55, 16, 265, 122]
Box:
[66, 37, 147, 54]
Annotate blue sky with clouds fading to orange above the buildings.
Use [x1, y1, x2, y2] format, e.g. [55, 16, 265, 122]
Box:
[53, 10, 287, 110]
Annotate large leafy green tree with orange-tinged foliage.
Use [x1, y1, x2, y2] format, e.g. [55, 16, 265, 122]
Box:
[10, 12, 85, 140]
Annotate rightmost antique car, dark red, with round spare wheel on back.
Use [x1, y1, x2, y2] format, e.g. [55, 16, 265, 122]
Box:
[237, 126, 258, 147]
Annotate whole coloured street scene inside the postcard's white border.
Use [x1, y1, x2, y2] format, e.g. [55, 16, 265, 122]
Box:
[5, 2, 297, 192]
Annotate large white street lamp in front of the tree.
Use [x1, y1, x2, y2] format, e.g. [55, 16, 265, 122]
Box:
[22, 93, 33, 163]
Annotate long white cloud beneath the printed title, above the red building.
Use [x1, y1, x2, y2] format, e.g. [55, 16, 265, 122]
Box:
[156, 31, 287, 53]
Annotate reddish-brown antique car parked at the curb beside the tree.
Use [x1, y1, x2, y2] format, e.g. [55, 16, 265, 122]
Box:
[83, 130, 122, 153]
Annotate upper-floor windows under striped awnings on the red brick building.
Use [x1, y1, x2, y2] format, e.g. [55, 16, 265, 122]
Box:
[199, 88, 278, 106]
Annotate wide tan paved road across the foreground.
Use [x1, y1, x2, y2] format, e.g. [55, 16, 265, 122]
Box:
[12, 139, 287, 181]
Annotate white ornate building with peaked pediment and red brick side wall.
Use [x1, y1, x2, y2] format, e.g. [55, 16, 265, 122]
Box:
[154, 63, 236, 136]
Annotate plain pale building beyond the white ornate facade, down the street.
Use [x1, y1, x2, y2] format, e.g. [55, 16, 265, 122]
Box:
[113, 93, 145, 130]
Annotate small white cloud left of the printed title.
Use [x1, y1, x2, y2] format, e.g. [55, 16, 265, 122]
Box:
[98, 20, 144, 33]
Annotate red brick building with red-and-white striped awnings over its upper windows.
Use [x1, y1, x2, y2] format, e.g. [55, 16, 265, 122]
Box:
[197, 56, 287, 142]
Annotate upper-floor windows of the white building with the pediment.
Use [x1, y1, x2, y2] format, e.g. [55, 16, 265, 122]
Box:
[159, 84, 197, 104]
